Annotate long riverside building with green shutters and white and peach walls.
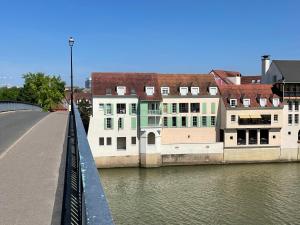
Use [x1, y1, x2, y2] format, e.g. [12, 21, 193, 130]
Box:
[88, 73, 223, 167]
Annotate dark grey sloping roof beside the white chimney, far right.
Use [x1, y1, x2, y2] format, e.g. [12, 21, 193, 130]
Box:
[273, 60, 300, 83]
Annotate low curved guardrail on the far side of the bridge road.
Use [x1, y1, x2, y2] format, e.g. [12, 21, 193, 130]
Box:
[0, 101, 42, 112]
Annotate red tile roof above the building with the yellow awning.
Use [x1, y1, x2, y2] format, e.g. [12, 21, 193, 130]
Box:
[219, 84, 279, 108]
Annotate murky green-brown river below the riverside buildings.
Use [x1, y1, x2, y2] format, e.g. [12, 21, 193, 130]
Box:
[100, 163, 300, 225]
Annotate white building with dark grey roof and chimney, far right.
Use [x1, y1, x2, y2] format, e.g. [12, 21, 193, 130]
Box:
[262, 56, 300, 160]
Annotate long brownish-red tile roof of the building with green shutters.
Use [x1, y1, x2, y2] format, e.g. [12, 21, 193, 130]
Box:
[92, 73, 217, 100]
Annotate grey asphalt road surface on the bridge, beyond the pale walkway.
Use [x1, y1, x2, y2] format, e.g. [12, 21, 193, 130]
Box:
[0, 111, 48, 155]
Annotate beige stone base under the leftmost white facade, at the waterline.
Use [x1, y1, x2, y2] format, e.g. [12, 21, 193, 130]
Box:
[94, 155, 140, 168]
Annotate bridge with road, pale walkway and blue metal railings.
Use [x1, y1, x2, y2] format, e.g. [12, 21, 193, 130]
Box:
[0, 102, 113, 225]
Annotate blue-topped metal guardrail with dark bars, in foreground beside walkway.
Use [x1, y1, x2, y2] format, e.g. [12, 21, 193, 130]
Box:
[61, 105, 114, 225]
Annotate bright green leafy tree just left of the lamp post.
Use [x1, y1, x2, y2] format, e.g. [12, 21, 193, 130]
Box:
[20, 73, 65, 111]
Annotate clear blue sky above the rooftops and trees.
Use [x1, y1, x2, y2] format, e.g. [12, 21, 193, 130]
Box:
[0, 0, 300, 86]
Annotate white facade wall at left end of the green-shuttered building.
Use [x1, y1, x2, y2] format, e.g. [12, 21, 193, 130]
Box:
[88, 97, 139, 160]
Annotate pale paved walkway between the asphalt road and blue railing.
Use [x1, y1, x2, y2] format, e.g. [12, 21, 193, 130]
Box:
[0, 112, 68, 225]
